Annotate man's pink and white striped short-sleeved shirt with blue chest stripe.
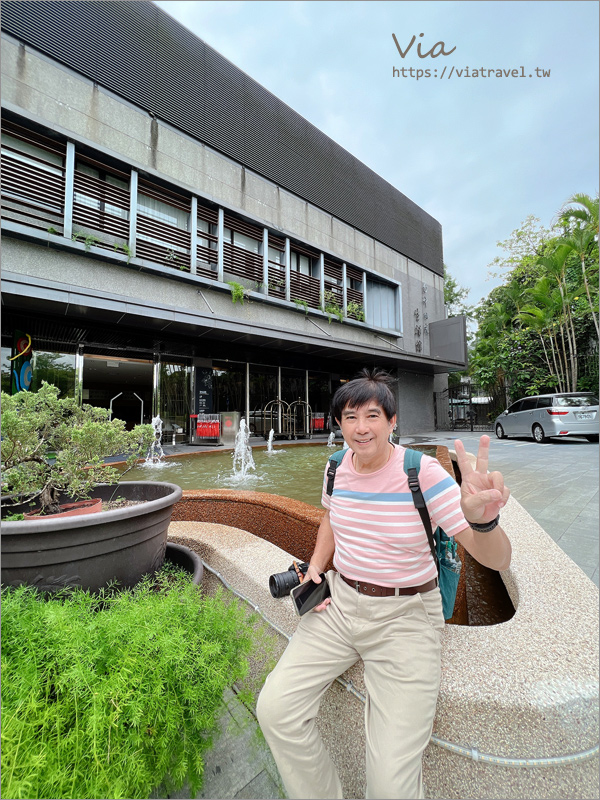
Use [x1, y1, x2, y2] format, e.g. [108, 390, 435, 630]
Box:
[321, 446, 469, 587]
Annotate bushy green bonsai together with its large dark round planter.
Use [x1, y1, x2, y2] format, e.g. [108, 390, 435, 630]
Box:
[1, 383, 181, 591]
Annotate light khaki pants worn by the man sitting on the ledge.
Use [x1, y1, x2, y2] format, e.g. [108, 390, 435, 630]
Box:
[257, 571, 444, 800]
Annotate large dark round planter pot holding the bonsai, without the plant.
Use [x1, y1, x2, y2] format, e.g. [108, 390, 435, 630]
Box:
[1, 481, 181, 591]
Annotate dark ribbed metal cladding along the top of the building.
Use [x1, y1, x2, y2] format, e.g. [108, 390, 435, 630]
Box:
[2, 0, 443, 275]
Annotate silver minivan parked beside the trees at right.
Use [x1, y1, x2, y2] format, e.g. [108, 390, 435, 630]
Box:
[494, 392, 598, 443]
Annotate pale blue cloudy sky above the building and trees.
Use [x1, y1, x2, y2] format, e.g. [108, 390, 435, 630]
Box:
[156, 0, 599, 304]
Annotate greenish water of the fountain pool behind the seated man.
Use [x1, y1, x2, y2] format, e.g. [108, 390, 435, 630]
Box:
[127, 442, 436, 508]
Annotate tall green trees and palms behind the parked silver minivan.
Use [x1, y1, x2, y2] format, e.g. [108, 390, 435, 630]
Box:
[471, 194, 598, 399]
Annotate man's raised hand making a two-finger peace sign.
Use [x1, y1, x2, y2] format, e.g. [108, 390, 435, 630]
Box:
[454, 436, 510, 524]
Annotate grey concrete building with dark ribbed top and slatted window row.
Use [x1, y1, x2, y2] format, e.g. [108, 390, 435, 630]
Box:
[2, 0, 466, 438]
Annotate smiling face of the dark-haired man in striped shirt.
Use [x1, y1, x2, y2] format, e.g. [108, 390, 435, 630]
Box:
[338, 401, 396, 466]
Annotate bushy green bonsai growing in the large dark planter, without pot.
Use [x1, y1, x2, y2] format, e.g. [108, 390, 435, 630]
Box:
[1, 382, 154, 514]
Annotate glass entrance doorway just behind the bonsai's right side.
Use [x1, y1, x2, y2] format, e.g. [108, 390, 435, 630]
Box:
[83, 355, 153, 430]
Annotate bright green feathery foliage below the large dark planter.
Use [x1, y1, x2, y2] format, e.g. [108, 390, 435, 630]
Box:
[2, 569, 268, 800]
